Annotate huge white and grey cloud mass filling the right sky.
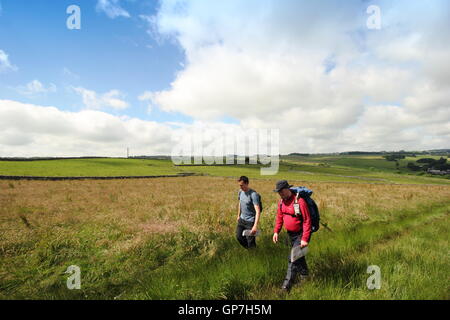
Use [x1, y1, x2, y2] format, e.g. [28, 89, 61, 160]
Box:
[145, 0, 450, 152]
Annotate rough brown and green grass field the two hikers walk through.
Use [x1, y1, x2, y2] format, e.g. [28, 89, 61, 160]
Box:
[0, 172, 450, 299]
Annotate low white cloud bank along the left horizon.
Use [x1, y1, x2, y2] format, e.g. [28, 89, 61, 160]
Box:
[0, 100, 172, 156]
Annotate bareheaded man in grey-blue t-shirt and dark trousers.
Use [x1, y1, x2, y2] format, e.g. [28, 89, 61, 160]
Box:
[236, 176, 262, 249]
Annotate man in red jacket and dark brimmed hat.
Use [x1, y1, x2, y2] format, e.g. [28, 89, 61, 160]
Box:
[273, 180, 311, 291]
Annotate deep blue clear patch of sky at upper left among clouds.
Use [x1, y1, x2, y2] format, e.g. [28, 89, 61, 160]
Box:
[0, 0, 190, 121]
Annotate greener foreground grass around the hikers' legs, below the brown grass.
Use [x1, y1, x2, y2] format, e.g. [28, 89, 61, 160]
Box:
[0, 201, 450, 299]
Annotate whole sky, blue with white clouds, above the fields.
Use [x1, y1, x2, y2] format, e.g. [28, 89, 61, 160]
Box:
[0, 0, 450, 157]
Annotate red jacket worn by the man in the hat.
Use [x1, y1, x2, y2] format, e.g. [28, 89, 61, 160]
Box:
[273, 193, 311, 242]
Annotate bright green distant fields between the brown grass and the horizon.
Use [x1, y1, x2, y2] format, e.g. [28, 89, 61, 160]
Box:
[0, 156, 450, 184]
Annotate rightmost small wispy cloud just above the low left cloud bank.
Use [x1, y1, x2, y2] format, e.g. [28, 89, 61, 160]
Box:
[72, 87, 129, 110]
